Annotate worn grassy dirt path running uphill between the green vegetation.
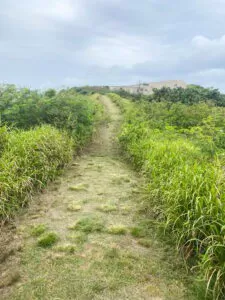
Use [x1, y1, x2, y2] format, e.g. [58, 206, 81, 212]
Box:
[0, 96, 193, 300]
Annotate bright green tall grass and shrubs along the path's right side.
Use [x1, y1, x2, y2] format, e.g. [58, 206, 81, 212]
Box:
[110, 92, 225, 299]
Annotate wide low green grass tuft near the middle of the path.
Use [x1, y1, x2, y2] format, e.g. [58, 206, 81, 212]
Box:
[70, 217, 104, 233]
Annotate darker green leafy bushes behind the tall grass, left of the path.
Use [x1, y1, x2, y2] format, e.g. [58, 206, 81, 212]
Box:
[0, 85, 97, 144]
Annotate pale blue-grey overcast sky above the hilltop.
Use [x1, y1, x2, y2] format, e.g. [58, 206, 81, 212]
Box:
[0, 0, 225, 91]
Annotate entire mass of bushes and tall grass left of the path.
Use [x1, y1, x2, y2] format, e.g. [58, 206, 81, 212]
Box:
[0, 85, 100, 219]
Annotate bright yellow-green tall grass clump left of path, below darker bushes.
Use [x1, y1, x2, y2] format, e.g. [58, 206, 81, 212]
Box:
[0, 125, 74, 219]
